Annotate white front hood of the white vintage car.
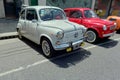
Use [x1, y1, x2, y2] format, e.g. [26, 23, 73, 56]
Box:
[41, 20, 82, 32]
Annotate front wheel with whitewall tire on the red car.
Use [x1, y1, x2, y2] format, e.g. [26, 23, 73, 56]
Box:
[85, 30, 98, 43]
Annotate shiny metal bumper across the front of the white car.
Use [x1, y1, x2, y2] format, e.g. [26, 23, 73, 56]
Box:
[54, 40, 84, 50]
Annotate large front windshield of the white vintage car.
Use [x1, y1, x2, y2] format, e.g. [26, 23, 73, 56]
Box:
[39, 8, 66, 21]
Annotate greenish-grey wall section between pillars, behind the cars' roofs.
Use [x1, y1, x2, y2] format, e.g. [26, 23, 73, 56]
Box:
[46, 0, 93, 9]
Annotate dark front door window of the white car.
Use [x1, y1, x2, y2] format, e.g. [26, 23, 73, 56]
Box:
[26, 9, 38, 20]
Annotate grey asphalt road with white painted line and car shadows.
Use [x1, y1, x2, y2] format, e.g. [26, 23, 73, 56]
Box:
[0, 34, 120, 80]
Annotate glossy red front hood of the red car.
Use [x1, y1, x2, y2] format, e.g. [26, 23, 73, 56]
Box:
[85, 18, 114, 25]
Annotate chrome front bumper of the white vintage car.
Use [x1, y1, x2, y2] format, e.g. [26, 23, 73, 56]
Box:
[54, 40, 84, 50]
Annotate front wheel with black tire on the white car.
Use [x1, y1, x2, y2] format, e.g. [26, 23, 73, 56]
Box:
[41, 38, 55, 58]
